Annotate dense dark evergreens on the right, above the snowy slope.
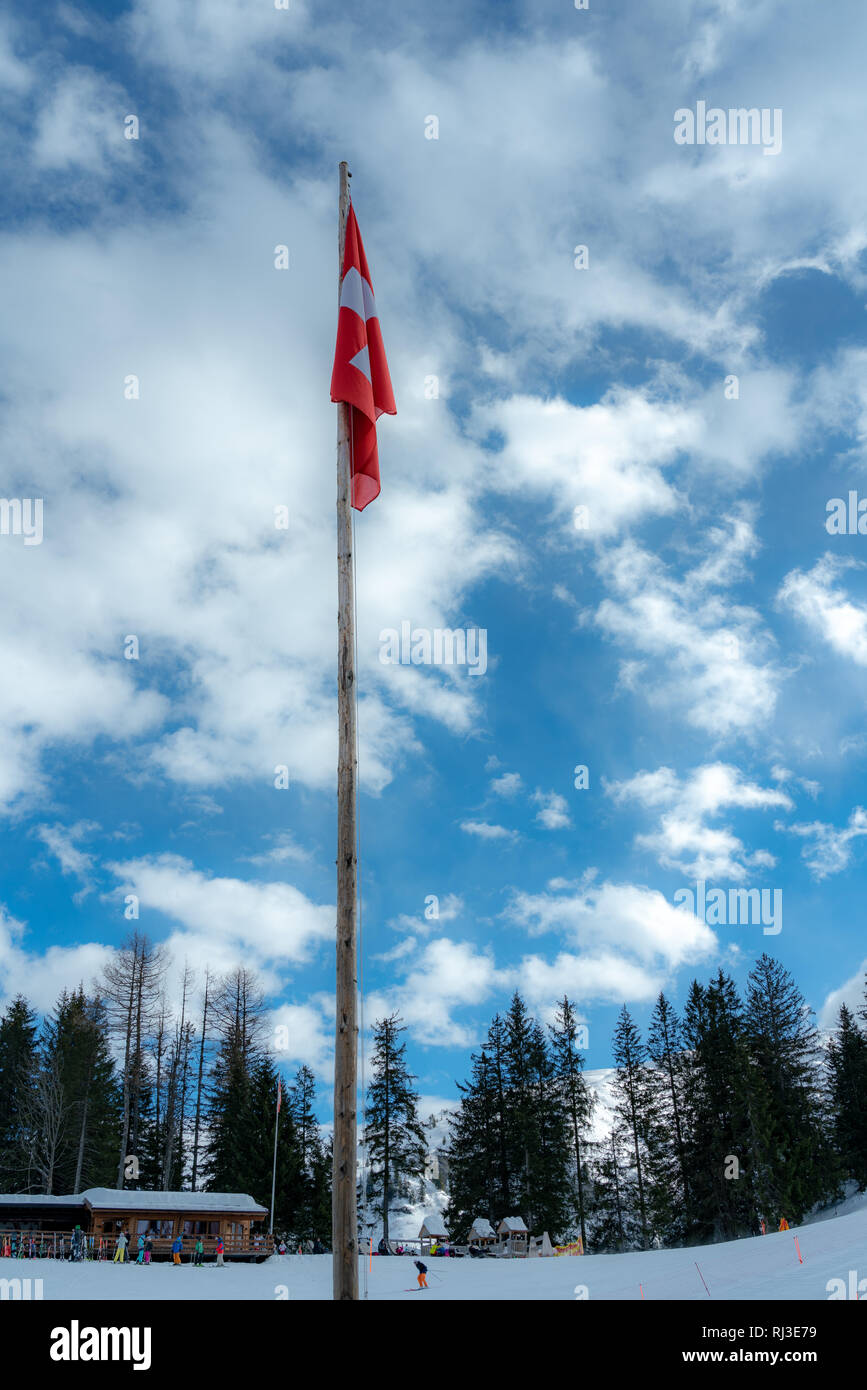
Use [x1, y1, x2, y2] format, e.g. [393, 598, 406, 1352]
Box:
[447, 955, 867, 1251]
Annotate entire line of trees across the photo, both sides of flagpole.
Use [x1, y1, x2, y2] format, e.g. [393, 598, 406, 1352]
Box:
[6, 934, 867, 1251]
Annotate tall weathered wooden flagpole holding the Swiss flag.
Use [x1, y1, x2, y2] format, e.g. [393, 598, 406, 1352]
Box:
[331, 163, 358, 1300]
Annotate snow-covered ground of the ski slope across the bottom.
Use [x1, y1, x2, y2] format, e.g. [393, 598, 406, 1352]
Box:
[11, 1194, 867, 1301]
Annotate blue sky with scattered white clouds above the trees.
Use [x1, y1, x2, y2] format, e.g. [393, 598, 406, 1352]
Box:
[0, 0, 867, 1118]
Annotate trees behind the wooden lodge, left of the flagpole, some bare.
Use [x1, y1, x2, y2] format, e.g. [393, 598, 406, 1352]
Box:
[0, 933, 331, 1243]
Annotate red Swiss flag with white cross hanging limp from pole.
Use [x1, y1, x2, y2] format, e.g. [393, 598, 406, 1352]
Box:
[331, 203, 397, 512]
